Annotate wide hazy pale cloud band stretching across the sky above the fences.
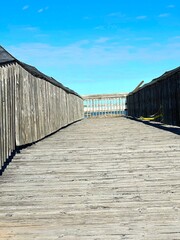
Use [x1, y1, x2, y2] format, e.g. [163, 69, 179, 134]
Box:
[9, 36, 180, 69]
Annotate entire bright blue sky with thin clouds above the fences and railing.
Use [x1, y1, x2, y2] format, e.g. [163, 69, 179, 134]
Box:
[0, 0, 180, 95]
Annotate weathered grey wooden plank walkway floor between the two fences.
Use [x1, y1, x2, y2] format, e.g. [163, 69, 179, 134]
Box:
[0, 118, 180, 240]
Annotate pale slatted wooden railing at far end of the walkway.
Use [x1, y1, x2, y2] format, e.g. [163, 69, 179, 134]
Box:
[83, 93, 127, 118]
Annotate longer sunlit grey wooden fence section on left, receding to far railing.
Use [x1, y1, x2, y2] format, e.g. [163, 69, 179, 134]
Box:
[16, 65, 83, 146]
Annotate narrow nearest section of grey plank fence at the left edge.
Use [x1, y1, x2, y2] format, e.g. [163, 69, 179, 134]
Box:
[0, 64, 15, 170]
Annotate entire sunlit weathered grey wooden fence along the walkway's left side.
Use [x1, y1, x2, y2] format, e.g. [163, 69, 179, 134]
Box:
[0, 62, 83, 173]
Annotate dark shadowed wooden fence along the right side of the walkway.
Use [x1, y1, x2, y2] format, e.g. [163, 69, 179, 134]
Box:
[127, 67, 180, 126]
